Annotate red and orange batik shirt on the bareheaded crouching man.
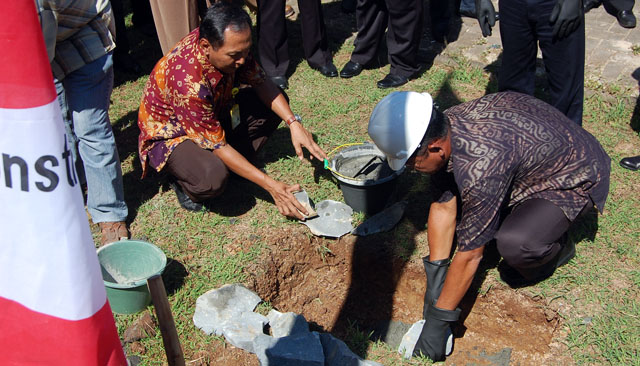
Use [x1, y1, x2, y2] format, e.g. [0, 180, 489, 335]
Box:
[138, 29, 265, 177]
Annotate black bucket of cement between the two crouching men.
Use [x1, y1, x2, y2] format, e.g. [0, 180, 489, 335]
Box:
[329, 142, 404, 215]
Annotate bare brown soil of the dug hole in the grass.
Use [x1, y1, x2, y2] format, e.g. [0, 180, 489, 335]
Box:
[250, 227, 573, 365]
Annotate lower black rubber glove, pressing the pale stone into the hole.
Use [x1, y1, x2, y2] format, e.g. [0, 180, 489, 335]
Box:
[413, 305, 460, 361]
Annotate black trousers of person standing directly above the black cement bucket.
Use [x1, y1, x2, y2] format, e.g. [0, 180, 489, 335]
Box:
[351, 0, 423, 78]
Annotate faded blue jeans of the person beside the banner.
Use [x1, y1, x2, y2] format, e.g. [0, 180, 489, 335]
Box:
[54, 53, 128, 223]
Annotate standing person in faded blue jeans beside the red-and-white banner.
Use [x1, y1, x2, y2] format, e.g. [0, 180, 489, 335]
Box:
[38, 0, 129, 245]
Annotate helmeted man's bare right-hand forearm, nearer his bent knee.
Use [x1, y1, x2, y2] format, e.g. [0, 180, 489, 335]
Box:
[436, 247, 484, 310]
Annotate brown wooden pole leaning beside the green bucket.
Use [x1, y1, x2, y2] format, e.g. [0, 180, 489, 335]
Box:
[147, 275, 184, 366]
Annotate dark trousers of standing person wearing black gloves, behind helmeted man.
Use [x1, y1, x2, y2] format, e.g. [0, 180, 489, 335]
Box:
[498, 0, 585, 125]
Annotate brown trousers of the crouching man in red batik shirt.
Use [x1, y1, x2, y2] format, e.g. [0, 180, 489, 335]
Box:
[163, 88, 282, 202]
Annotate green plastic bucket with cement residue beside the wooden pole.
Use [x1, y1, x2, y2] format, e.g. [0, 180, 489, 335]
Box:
[98, 240, 167, 314]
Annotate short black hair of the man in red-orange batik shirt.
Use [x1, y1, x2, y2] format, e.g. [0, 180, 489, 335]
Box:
[200, 1, 251, 49]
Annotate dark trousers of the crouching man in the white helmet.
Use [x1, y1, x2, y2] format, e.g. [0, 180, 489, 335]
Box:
[495, 198, 592, 271]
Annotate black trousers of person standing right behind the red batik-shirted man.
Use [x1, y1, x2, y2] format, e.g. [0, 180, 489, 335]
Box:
[258, 0, 332, 76]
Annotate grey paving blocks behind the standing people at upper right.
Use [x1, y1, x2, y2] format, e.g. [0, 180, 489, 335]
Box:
[434, 1, 640, 94]
